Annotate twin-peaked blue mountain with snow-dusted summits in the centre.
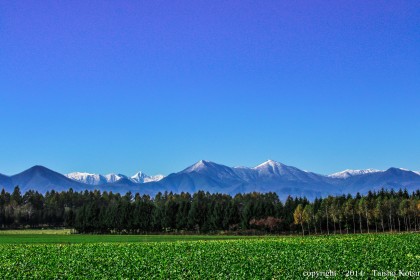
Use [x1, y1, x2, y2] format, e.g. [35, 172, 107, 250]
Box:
[149, 160, 338, 198]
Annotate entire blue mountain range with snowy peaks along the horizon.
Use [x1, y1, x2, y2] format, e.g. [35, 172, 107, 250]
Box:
[0, 160, 420, 199]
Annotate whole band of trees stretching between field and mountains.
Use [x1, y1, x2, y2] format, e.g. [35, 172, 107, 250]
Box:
[0, 186, 420, 234]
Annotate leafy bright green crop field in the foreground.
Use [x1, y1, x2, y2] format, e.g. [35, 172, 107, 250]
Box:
[0, 233, 420, 279]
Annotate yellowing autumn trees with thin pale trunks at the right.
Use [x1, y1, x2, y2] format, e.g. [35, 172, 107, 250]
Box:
[293, 190, 420, 234]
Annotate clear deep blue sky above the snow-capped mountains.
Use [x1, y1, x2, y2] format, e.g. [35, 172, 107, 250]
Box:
[0, 0, 420, 175]
